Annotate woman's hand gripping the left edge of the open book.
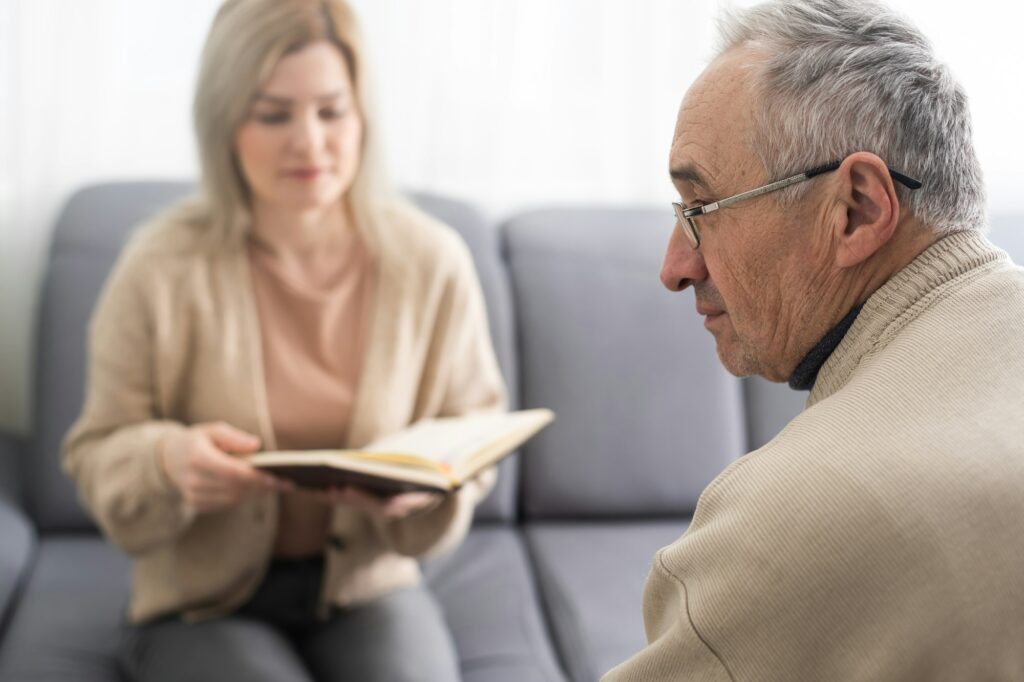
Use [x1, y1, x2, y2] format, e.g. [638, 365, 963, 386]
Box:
[160, 422, 293, 514]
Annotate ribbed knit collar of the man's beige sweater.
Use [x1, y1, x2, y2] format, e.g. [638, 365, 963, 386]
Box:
[807, 231, 1008, 408]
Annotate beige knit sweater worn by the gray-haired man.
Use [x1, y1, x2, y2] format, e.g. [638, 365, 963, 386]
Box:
[604, 233, 1024, 682]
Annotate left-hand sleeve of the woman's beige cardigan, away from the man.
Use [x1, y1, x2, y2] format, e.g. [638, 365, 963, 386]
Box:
[62, 247, 194, 555]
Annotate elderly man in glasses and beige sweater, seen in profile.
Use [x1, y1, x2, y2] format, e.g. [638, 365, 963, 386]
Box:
[604, 0, 1024, 682]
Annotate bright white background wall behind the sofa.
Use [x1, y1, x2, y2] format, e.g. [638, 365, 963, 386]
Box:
[0, 0, 1024, 431]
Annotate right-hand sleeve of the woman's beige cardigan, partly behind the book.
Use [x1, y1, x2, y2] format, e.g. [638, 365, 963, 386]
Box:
[382, 232, 506, 556]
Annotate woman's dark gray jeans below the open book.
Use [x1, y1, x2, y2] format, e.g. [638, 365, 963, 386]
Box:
[122, 561, 459, 682]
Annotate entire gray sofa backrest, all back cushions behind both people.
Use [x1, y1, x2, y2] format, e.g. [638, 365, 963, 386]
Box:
[25, 181, 1024, 530]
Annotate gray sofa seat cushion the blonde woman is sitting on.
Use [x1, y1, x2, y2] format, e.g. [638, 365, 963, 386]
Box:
[0, 524, 563, 682]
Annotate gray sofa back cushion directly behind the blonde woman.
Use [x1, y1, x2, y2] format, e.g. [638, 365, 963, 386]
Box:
[25, 181, 517, 531]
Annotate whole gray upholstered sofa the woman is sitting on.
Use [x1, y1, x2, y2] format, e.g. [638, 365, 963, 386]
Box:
[0, 182, 1011, 682]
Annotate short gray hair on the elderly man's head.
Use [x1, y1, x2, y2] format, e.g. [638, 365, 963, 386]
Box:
[716, 0, 986, 235]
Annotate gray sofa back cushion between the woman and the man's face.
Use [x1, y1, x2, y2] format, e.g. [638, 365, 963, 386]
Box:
[504, 209, 746, 519]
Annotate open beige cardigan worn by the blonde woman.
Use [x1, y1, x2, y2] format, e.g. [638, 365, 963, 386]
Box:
[63, 199, 505, 622]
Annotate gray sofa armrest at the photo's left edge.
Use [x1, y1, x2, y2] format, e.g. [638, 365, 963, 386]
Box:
[0, 432, 36, 634]
